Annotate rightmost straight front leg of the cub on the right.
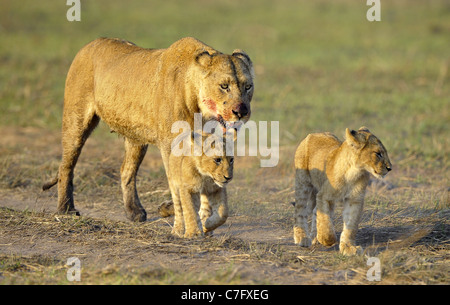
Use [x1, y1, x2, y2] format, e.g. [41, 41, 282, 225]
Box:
[339, 199, 364, 255]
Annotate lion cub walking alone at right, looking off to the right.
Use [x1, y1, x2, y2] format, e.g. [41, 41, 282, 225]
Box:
[294, 127, 391, 255]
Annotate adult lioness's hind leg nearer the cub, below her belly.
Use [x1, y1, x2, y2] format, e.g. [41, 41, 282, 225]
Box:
[120, 138, 148, 221]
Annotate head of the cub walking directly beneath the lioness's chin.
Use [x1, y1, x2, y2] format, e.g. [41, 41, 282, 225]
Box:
[193, 133, 234, 187]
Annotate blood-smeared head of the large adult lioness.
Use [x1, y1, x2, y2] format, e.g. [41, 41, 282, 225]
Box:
[196, 50, 254, 128]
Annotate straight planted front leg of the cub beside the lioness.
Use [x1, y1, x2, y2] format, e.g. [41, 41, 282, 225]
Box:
[182, 189, 204, 238]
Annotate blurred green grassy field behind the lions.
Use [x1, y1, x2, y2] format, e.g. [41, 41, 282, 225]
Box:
[0, 0, 450, 167]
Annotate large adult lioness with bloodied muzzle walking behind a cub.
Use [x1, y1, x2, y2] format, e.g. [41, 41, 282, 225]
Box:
[43, 38, 254, 221]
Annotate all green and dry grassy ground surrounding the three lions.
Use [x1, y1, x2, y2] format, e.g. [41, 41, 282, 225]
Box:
[0, 0, 450, 284]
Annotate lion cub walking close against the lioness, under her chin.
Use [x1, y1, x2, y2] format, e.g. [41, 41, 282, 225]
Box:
[168, 133, 234, 238]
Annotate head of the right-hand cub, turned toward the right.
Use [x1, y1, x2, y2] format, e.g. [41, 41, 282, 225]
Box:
[345, 127, 392, 178]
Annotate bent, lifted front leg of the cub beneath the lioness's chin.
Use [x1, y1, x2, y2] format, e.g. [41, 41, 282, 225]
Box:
[200, 188, 228, 233]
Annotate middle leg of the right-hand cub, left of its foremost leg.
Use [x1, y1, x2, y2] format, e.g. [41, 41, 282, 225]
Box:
[316, 193, 337, 246]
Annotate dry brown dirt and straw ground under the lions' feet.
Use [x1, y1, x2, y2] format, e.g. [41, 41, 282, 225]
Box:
[0, 126, 450, 284]
